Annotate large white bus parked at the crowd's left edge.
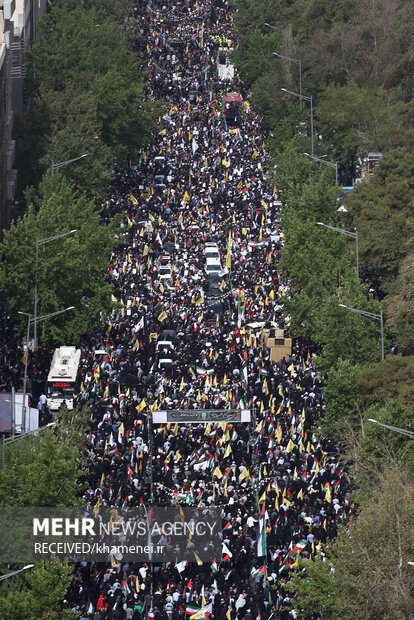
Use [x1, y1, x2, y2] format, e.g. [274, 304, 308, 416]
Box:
[46, 347, 81, 411]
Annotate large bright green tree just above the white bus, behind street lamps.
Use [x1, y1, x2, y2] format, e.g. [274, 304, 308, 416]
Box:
[1, 172, 117, 344]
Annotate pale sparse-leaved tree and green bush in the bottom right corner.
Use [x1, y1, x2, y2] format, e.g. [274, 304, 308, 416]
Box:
[289, 467, 414, 620]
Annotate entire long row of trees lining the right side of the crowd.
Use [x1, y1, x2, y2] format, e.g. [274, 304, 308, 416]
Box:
[230, 0, 414, 620]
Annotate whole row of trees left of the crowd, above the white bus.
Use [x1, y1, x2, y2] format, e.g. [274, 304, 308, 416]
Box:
[0, 0, 162, 344]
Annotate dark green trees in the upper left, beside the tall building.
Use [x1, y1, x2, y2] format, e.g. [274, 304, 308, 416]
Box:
[15, 0, 158, 197]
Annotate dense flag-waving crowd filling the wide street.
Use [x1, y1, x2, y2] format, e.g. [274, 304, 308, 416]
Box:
[56, 0, 355, 620]
